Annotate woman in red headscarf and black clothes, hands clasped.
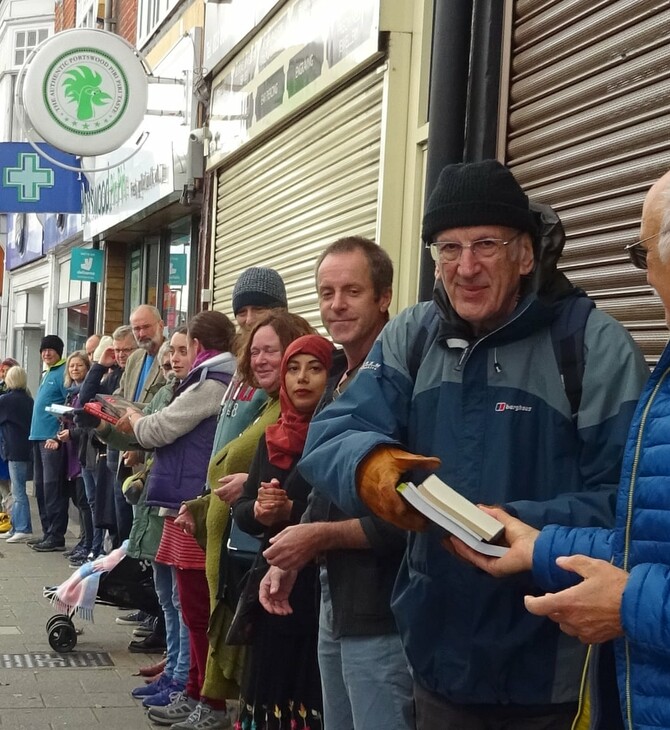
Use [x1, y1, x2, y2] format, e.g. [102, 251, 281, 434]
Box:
[233, 335, 333, 730]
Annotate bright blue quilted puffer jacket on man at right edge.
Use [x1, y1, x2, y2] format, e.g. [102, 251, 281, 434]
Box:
[533, 347, 670, 730]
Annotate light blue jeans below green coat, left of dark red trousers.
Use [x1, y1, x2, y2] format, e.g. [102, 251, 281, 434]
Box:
[151, 560, 191, 685]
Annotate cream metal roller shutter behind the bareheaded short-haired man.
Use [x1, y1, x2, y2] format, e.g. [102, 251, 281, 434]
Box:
[213, 72, 384, 326]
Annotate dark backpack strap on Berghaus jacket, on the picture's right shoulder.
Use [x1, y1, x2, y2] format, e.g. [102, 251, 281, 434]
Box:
[551, 296, 595, 418]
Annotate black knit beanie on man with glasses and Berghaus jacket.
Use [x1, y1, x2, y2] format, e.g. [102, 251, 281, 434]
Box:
[421, 160, 537, 244]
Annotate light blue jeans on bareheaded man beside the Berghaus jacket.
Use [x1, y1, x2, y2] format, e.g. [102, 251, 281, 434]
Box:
[319, 568, 414, 730]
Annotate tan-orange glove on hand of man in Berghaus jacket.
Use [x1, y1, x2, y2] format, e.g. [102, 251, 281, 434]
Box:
[356, 446, 441, 531]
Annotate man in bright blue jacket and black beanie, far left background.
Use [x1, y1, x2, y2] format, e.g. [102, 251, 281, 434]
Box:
[28, 335, 69, 553]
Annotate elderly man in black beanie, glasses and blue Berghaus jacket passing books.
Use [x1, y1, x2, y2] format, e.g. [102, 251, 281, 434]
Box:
[300, 160, 649, 730]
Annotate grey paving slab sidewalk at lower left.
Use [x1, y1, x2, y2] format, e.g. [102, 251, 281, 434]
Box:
[0, 506, 160, 730]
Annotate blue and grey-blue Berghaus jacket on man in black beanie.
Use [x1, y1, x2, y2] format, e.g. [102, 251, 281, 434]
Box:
[299, 274, 649, 705]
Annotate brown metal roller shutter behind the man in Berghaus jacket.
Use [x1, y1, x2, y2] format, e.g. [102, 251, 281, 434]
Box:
[505, 0, 670, 361]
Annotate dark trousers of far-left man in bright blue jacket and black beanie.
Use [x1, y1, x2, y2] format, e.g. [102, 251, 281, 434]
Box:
[33, 441, 70, 545]
